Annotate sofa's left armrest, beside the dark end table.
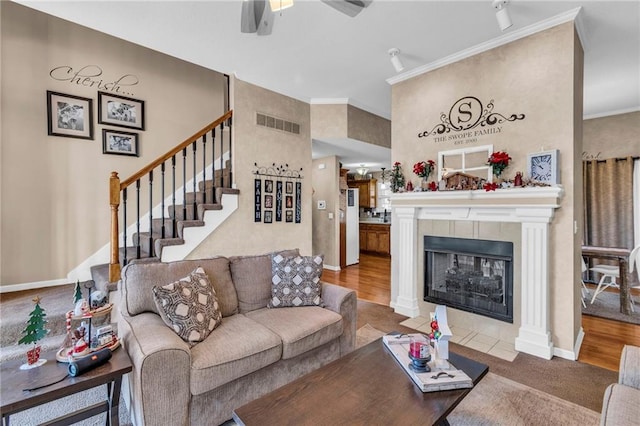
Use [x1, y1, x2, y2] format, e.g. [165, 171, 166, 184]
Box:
[118, 312, 191, 425]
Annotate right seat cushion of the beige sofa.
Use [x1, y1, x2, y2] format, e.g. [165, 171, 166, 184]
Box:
[246, 306, 343, 359]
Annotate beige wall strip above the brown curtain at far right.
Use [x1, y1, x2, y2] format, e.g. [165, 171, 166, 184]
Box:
[582, 111, 640, 160]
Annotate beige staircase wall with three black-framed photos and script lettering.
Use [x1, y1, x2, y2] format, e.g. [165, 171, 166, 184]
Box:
[0, 1, 225, 285]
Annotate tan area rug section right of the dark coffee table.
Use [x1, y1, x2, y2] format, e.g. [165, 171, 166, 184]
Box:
[447, 373, 600, 426]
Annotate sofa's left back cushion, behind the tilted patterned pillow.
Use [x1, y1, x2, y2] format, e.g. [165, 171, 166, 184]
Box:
[120, 257, 238, 317]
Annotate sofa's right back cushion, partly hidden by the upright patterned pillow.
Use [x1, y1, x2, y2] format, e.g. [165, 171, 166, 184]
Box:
[229, 249, 299, 314]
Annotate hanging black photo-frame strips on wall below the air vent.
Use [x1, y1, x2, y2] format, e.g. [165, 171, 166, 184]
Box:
[253, 163, 304, 223]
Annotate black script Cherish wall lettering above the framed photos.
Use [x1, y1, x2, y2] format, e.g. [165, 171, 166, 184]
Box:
[49, 65, 140, 96]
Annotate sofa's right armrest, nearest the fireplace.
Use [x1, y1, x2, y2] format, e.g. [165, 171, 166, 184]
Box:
[322, 282, 358, 356]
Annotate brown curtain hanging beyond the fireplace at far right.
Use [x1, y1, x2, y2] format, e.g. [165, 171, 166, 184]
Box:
[582, 157, 635, 276]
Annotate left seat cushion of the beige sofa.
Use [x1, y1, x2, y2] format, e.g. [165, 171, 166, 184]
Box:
[190, 315, 282, 395]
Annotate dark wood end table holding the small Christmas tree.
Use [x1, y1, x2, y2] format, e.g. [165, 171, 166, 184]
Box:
[0, 348, 132, 426]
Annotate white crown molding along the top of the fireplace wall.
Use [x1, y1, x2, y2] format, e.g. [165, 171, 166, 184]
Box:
[386, 7, 587, 86]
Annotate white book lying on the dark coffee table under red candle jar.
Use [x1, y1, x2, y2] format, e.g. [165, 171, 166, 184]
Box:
[382, 333, 473, 392]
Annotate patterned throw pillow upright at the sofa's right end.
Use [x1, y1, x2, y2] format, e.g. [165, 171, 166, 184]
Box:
[268, 254, 324, 308]
